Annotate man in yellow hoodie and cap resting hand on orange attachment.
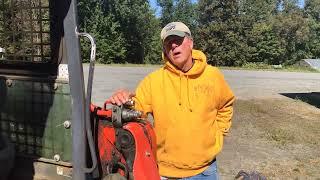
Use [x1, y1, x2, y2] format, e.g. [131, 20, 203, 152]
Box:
[109, 22, 235, 180]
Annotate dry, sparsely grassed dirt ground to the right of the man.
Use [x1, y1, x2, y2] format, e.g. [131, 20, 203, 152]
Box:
[217, 98, 320, 180]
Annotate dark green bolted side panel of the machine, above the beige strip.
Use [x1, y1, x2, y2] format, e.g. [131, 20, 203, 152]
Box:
[0, 76, 71, 162]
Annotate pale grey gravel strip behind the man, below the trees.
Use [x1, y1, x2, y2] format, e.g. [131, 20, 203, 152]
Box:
[84, 65, 320, 105]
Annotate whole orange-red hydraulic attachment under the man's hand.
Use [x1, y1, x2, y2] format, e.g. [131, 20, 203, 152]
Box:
[90, 102, 160, 180]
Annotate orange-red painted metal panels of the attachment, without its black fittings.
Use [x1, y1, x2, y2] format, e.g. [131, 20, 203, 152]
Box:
[90, 103, 160, 180]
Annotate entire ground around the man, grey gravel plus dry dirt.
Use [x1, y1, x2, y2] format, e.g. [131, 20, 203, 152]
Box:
[85, 65, 320, 180]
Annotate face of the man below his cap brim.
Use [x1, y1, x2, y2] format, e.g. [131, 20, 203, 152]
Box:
[163, 36, 193, 70]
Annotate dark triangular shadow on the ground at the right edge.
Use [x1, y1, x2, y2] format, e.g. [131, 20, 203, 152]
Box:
[280, 92, 320, 108]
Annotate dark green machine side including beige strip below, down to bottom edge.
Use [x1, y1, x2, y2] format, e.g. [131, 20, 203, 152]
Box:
[0, 76, 72, 179]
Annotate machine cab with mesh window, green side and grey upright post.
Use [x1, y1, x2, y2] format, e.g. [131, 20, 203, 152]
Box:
[0, 0, 94, 180]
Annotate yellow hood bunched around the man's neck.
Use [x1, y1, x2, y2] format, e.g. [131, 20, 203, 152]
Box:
[162, 49, 207, 76]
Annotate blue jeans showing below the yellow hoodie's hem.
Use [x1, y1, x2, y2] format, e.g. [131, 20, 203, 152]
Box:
[161, 161, 219, 180]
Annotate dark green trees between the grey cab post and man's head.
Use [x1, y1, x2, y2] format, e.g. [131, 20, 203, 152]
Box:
[78, 0, 161, 63]
